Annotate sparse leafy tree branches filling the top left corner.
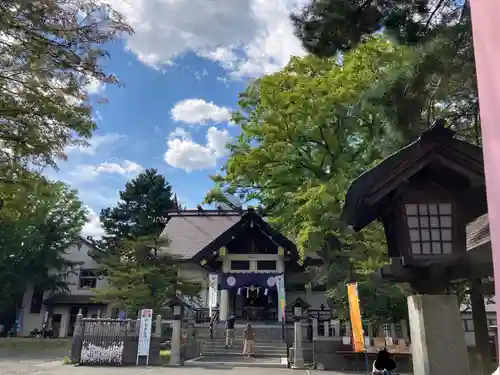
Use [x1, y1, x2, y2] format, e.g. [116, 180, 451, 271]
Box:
[0, 0, 132, 169]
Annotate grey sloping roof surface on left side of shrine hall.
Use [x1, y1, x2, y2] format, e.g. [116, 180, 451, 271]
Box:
[160, 210, 241, 259]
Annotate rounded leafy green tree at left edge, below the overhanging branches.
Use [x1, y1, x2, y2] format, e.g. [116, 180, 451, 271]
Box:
[0, 172, 87, 322]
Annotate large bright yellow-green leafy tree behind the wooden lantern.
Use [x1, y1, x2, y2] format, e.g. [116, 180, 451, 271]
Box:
[207, 36, 414, 319]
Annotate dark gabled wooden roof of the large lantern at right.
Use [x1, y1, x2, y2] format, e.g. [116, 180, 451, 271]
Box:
[342, 120, 484, 230]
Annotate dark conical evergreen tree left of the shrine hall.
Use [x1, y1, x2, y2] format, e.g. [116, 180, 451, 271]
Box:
[95, 169, 199, 312]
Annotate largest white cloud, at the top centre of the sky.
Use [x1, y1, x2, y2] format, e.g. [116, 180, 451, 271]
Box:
[102, 0, 308, 77]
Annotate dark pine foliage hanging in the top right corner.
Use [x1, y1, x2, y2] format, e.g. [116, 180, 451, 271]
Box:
[292, 0, 481, 144]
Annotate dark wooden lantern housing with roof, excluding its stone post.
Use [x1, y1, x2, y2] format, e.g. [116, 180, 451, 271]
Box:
[342, 120, 487, 294]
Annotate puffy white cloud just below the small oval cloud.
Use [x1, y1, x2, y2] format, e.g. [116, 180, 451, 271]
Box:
[164, 126, 230, 172]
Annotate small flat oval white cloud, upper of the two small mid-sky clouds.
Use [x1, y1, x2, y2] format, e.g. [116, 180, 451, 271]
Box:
[170, 99, 231, 125]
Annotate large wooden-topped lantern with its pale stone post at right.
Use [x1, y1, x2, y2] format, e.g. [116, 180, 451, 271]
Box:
[342, 120, 487, 375]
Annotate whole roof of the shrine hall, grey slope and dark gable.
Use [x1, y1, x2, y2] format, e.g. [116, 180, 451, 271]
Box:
[160, 210, 298, 262]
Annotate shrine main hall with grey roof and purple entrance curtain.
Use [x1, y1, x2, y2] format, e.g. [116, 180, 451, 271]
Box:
[161, 208, 327, 324]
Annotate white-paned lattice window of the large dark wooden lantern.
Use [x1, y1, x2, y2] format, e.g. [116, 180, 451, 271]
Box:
[405, 203, 453, 255]
